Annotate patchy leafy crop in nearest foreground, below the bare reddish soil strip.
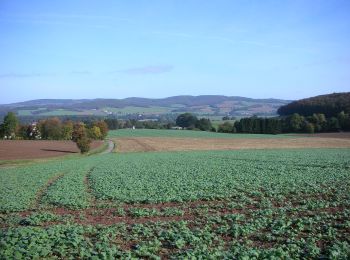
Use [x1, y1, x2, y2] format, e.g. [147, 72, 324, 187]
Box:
[0, 204, 350, 259]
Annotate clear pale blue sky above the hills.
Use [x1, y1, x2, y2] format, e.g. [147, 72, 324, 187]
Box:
[0, 0, 350, 104]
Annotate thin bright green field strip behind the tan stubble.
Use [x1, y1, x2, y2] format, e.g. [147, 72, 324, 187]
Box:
[108, 129, 295, 139]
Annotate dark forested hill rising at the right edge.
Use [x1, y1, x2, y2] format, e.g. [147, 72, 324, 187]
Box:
[277, 92, 350, 117]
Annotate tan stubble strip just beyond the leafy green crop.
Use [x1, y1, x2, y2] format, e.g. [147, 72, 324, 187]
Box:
[114, 137, 350, 152]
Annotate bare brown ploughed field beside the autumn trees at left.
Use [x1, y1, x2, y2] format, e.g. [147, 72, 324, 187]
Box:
[0, 140, 103, 160]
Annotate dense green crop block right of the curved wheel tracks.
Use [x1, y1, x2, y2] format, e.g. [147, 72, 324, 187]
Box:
[90, 149, 350, 203]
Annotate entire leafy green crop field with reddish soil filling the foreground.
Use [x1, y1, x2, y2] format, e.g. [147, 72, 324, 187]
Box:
[0, 149, 350, 259]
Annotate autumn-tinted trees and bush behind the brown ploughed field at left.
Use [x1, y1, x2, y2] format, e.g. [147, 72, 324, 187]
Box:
[0, 112, 108, 153]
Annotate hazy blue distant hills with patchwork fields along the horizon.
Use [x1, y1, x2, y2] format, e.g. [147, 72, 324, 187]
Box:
[0, 95, 290, 117]
